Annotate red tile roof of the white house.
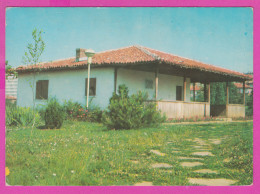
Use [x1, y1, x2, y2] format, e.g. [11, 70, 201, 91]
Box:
[17, 46, 251, 80]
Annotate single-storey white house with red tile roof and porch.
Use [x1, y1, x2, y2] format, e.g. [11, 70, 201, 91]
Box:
[17, 46, 251, 118]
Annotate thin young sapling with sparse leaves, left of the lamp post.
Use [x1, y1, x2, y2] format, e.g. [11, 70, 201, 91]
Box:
[23, 28, 45, 126]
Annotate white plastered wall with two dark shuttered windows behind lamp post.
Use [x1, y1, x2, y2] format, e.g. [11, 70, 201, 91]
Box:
[17, 68, 114, 108]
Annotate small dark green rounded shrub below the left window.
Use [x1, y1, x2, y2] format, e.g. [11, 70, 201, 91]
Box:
[44, 98, 65, 129]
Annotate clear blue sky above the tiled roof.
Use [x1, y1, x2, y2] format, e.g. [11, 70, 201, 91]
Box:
[6, 7, 253, 73]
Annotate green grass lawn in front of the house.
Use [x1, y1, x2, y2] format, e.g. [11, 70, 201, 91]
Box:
[6, 121, 253, 185]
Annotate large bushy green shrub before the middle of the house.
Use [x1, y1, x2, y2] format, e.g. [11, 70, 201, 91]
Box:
[102, 85, 165, 129]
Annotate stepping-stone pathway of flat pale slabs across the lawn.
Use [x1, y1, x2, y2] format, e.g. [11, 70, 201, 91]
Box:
[147, 133, 237, 186]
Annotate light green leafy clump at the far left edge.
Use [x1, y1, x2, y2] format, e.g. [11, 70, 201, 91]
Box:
[5, 104, 41, 127]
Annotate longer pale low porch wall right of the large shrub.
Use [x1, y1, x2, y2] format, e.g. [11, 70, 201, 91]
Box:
[156, 101, 210, 119]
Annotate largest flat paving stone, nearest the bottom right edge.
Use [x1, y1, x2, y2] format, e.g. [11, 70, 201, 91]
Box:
[188, 178, 237, 186]
